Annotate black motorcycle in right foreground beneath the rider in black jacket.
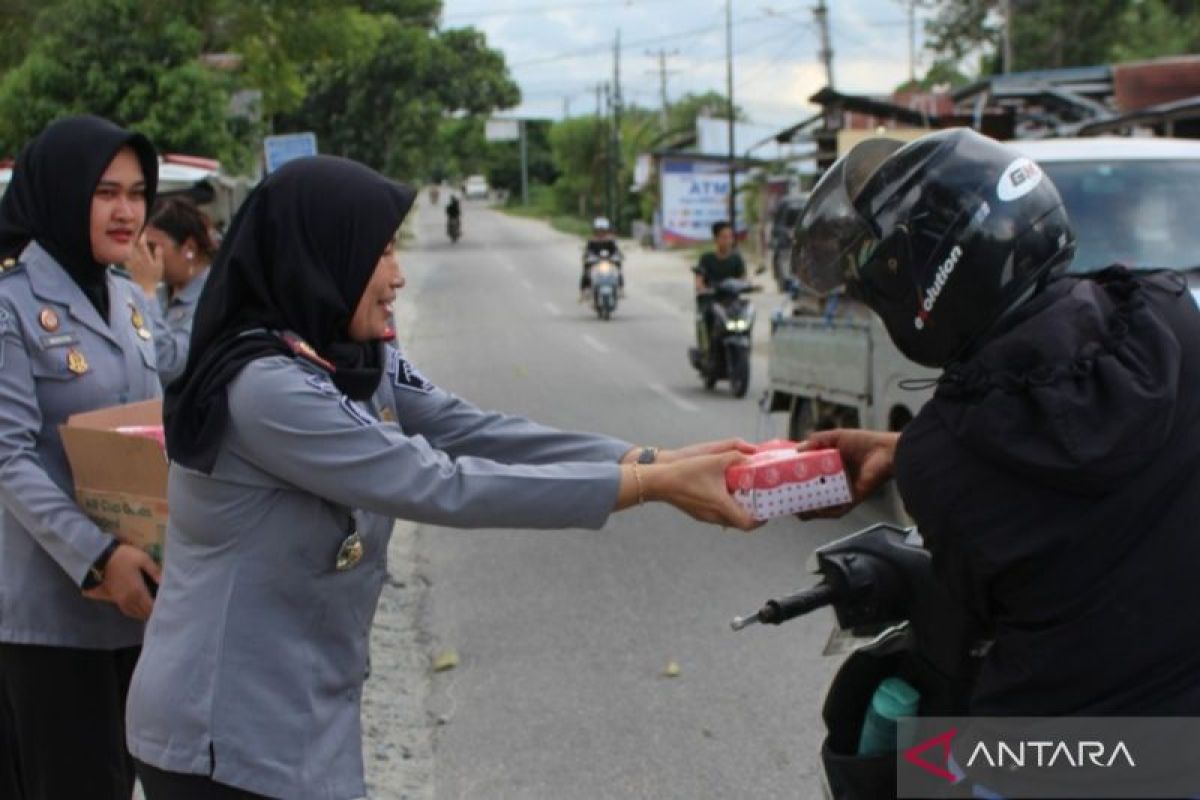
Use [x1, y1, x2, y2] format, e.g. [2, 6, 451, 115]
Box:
[731, 524, 986, 800]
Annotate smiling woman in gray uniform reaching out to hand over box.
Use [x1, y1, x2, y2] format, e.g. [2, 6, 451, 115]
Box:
[127, 157, 754, 800]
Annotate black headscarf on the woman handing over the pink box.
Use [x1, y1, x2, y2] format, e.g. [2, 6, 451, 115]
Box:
[164, 156, 415, 473]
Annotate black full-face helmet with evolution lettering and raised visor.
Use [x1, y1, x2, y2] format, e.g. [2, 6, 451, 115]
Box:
[792, 128, 1075, 367]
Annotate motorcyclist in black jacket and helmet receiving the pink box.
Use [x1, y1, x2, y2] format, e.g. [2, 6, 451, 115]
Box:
[793, 130, 1200, 716]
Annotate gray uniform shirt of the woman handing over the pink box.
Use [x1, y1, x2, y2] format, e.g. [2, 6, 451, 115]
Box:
[127, 348, 631, 800]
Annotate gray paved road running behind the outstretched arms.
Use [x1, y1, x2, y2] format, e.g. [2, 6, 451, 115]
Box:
[367, 195, 892, 800]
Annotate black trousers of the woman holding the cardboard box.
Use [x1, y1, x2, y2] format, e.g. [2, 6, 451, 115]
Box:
[0, 643, 142, 800]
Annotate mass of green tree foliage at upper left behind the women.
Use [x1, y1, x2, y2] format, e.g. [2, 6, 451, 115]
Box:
[0, 0, 516, 179]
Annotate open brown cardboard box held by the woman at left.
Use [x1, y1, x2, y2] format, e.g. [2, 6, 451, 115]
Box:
[59, 399, 167, 561]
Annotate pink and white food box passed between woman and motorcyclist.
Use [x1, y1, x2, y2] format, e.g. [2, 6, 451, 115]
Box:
[725, 443, 852, 519]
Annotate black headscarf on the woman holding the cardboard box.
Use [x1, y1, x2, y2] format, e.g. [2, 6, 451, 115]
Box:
[0, 116, 158, 320]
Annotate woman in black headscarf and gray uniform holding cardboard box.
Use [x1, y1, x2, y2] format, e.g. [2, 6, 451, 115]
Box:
[0, 116, 160, 800]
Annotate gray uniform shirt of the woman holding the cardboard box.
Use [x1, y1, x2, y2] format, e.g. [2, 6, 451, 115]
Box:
[0, 242, 161, 650]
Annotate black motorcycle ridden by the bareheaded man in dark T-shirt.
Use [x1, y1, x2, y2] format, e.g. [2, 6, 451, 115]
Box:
[688, 278, 760, 397]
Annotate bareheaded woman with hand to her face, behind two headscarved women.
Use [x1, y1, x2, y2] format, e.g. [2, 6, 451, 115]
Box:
[128, 197, 216, 386]
